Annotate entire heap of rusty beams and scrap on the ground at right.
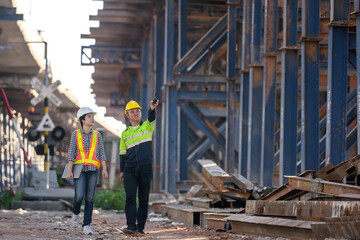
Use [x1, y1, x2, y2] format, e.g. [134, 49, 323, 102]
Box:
[163, 156, 360, 239]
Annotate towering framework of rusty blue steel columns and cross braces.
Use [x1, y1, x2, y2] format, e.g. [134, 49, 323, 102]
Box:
[83, 0, 360, 193]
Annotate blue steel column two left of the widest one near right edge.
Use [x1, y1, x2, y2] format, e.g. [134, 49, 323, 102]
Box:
[279, 0, 298, 185]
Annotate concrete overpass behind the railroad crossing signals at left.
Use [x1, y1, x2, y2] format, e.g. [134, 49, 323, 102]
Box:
[0, 0, 120, 191]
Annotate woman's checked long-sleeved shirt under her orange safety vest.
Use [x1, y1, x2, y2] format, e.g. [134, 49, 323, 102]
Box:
[68, 129, 106, 172]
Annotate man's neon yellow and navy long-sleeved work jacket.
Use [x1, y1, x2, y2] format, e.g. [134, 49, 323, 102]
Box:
[120, 109, 156, 172]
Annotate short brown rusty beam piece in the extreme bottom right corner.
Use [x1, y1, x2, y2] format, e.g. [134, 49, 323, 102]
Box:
[311, 221, 360, 239]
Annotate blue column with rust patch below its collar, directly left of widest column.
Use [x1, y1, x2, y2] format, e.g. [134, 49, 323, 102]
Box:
[301, 0, 320, 172]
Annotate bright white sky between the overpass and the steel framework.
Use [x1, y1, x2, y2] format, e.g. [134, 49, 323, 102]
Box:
[17, 0, 125, 135]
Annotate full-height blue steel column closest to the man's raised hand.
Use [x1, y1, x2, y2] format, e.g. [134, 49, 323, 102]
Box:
[163, 0, 177, 194]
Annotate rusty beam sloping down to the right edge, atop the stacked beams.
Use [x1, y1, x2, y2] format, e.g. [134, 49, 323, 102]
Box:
[286, 176, 360, 196]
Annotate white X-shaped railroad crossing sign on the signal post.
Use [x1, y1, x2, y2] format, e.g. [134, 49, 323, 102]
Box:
[30, 78, 62, 107]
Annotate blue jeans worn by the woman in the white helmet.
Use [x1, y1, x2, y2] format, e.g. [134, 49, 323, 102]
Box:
[73, 170, 99, 226]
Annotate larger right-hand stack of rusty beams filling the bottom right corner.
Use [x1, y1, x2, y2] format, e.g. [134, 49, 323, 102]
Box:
[222, 156, 360, 239]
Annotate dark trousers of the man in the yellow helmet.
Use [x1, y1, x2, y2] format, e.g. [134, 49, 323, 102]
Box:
[124, 164, 152, 230]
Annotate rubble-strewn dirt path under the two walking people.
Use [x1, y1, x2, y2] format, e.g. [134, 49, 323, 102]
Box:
[0, 209, 262, 240]
